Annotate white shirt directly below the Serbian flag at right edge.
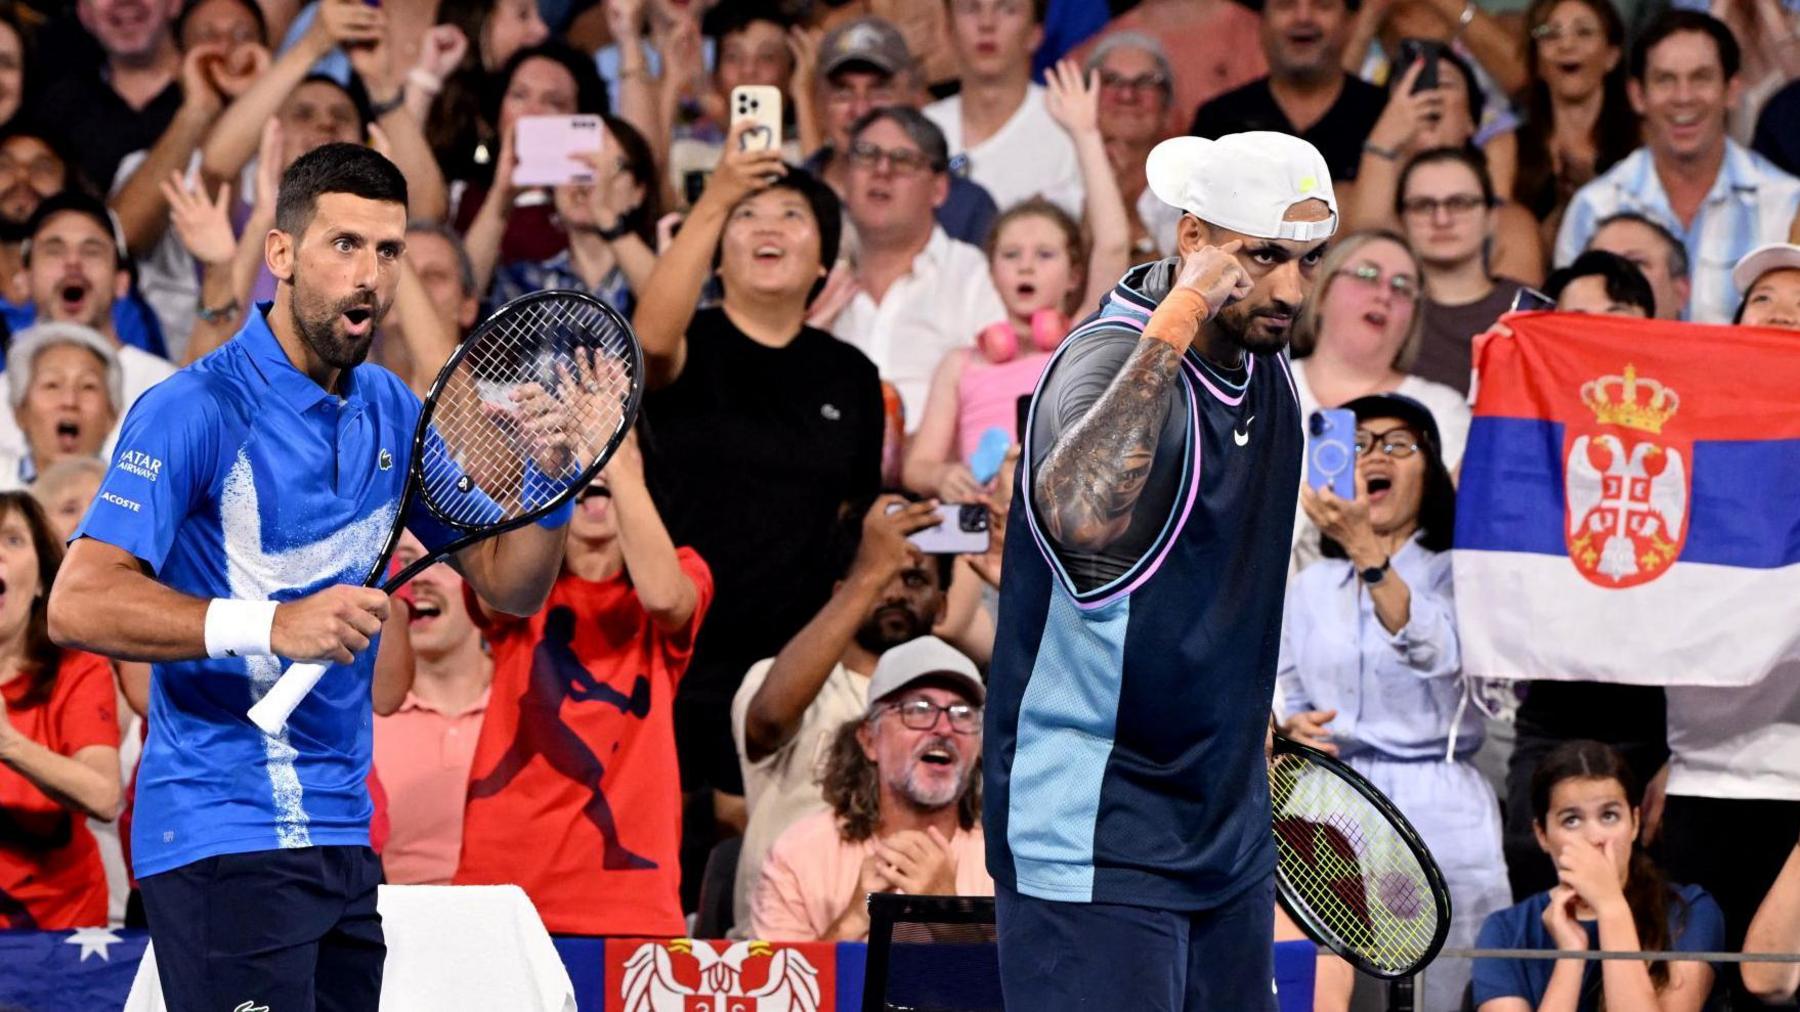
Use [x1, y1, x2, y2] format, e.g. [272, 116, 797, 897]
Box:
[1665, 661, 1800, 801]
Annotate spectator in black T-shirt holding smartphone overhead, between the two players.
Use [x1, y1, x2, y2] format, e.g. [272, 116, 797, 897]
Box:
[632, 121, 884, 907]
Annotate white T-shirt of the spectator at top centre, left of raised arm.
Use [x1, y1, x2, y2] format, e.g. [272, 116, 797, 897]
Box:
[925, 85, 1082, 221]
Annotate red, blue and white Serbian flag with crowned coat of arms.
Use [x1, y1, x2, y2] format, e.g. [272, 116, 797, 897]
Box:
[1454, 313, 1800, 686]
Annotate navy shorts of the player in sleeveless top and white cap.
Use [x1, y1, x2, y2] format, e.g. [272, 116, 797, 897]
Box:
[994, 877, 1276, 1012]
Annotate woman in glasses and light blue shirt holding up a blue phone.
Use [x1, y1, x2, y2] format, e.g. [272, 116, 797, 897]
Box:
[1276, 390, 1512, 1008]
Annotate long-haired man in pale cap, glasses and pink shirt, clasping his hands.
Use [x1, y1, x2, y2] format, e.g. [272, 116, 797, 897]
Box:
[751, 636, 994, 942]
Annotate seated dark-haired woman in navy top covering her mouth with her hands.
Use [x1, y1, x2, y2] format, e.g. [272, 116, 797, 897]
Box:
[1474, 742, 1724, 1012]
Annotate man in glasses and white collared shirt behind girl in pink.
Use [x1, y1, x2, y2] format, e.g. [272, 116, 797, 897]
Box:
[826, 106, 1006, 430]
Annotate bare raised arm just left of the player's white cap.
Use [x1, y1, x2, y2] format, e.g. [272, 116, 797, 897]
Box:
[1044, 59, 1130, 306]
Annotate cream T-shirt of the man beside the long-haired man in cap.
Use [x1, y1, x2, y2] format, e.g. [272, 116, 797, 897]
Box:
[731, 657, 869, 931]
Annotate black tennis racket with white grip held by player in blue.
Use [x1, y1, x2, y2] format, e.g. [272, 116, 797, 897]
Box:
[250, 290, 644, 735]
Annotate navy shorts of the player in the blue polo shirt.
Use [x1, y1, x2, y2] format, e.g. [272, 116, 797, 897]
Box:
[139, 846, 387, 1012]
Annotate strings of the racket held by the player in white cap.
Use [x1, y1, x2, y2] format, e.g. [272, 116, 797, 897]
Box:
[1269, 753, 1438, 972]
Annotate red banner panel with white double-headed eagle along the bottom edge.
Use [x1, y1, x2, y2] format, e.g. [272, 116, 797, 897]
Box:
[607, 938, 835, 1012]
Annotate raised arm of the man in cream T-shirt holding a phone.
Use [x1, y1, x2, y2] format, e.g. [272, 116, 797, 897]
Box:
[743, 495, 936, 762]
